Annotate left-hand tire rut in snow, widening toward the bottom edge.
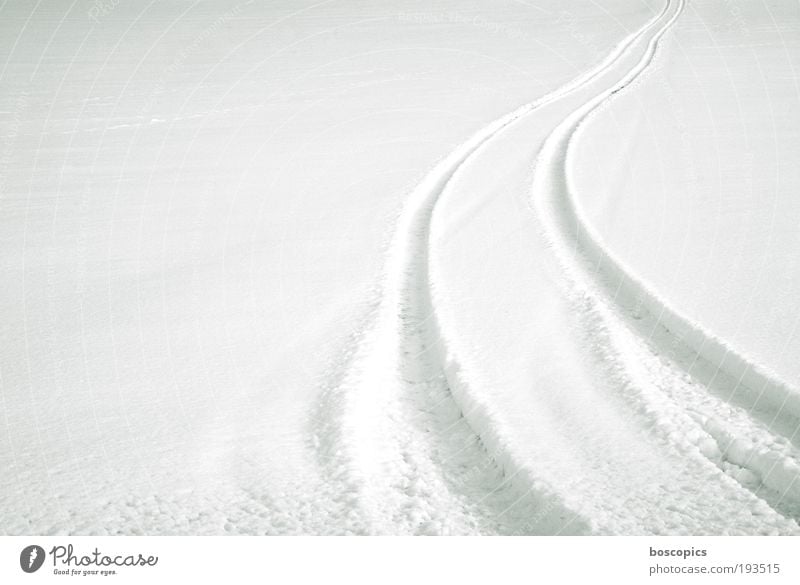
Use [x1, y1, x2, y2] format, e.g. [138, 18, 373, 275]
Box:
[313, 4, 674, 534]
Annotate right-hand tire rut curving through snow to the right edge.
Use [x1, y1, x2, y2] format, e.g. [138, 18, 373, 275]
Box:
[532, 0, 800, 519]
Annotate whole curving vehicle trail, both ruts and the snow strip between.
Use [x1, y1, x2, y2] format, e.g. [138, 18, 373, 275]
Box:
[312, 2, 800, 534]
